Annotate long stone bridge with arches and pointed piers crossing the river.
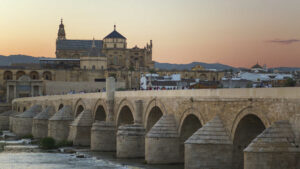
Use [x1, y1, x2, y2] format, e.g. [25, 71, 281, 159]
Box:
[9, 79, 300, 169]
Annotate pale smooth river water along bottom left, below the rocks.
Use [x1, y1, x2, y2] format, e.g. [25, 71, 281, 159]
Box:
[0, 152, 184, 169]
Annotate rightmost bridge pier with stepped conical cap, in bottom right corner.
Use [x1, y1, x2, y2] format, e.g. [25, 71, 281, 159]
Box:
[244, 120, 300, 169]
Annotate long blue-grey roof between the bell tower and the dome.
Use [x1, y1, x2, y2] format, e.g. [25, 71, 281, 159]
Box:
[56, 40, 102, 51]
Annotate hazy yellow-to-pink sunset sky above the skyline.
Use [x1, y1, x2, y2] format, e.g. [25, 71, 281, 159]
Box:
[0, 0, 300, 67]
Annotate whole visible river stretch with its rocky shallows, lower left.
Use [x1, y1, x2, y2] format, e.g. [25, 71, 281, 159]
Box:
[0, 132, 184, 169]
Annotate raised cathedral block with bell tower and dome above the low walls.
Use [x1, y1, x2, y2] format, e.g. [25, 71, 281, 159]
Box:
[56, 21, 154, 70]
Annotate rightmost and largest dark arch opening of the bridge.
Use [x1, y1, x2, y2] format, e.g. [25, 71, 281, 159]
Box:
[232, 114, 266, 169]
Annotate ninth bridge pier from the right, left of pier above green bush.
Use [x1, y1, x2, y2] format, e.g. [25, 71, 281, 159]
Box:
[13, 105, 42, 137]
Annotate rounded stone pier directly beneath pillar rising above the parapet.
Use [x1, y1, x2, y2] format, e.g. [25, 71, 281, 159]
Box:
[91, 121, 116, 151]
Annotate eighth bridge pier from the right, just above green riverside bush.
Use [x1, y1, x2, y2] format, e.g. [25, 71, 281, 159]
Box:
[32, 106, 55, 138]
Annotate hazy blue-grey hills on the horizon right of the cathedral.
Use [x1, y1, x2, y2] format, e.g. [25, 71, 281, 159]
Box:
[154, 62, 237, 70]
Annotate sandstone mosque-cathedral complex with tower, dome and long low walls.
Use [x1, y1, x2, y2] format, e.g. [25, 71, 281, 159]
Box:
[0, 20, 224, 102]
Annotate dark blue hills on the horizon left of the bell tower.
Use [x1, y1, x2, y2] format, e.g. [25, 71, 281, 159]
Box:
[0, 55, 44, 66]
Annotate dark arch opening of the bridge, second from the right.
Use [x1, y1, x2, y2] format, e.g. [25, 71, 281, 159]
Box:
[179, 113, 202, 161]
